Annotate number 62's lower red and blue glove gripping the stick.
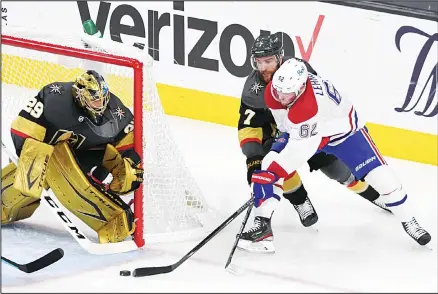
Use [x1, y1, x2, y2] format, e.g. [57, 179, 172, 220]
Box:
[251, 170, 281, 207]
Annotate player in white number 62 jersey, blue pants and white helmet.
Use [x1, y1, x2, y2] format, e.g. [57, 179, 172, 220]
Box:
[243, 59, 431, 246]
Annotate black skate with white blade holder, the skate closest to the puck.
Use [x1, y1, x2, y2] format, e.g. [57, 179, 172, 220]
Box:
[237, 216, 275, 253]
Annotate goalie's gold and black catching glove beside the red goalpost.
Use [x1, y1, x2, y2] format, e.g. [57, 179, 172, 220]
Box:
[90, 144, 144, 195]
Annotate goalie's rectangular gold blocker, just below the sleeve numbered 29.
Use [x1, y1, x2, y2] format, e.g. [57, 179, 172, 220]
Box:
[14, 138, 53, 198]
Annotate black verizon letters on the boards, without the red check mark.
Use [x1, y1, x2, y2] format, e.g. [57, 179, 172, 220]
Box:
[77, 1, 295, 77]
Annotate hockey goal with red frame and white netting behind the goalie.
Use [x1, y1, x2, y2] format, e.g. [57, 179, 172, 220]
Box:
[1, 27, 216, 247]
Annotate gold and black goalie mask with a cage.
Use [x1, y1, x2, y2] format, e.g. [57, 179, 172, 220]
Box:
[73, 70, 110, 122]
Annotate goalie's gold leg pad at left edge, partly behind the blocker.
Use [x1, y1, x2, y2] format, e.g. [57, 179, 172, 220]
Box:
[1, 163, 40, 225]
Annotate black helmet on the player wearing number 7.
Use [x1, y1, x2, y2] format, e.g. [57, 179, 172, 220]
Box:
[251, 32, 284, 70]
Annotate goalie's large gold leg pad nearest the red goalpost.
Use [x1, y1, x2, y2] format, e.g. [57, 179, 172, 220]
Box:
[47, 142, 135, 243]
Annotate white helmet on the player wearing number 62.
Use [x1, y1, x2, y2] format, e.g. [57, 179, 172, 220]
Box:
[271, 58, 309, 106]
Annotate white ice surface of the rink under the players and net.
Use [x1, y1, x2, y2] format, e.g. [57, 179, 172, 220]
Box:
[1, 117, 438, 293]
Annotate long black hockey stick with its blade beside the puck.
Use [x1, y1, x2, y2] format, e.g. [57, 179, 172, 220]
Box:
[132, 198, 253, 277]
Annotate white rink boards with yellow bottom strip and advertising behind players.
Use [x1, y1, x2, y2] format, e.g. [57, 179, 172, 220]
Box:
[2, 1, 438, 165]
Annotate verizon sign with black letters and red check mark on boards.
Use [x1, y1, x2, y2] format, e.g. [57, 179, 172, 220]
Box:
[77, 1, 324, 78]
